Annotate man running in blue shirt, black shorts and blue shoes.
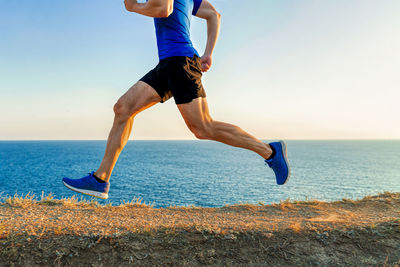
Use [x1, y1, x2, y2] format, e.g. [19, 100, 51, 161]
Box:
[63, 0, 290, 199]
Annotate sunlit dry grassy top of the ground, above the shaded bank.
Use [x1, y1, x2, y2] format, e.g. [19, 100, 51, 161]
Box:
[0, 192, 400, 240]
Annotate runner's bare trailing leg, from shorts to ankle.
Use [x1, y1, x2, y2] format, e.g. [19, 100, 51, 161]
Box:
[178, 97, 272, 159]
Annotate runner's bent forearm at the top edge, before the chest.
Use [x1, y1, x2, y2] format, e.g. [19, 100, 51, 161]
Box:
[124, 0, 174, 18]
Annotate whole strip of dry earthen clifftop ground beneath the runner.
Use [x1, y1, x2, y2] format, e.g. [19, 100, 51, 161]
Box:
[0, 193, 400, 266]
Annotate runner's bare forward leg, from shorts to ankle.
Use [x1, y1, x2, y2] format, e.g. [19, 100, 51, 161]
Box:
[95, 81, 161, 182]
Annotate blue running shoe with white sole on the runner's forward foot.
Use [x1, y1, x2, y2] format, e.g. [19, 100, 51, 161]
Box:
[63, 172, 110, 199]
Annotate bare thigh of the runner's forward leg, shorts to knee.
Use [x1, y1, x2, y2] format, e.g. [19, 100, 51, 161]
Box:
[117, 81, 161, 114]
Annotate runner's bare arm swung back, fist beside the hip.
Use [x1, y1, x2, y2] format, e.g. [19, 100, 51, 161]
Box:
[196, 0, 221, 72]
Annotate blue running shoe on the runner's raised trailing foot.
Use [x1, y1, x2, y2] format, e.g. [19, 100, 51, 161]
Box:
[265, 141, 290, 185]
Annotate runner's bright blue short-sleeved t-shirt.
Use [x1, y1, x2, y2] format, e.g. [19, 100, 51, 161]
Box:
[154, 0, 202, 60]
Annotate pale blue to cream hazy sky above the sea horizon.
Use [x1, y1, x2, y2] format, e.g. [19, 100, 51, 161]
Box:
[0, 0, 400, 140]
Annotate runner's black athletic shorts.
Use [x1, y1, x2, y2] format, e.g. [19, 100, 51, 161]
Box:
[140, 55, 206, 105]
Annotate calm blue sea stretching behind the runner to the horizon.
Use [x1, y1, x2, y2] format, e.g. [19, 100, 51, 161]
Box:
[0, 141, 400, 207]
